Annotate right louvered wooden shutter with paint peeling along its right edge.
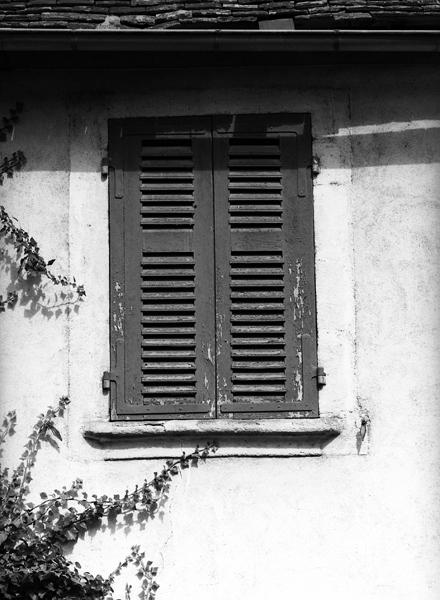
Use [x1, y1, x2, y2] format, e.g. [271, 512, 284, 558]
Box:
[213, 114, 318, 418]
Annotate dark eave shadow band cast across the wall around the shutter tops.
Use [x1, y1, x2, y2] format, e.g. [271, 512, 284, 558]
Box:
[4, 65, 440, 173]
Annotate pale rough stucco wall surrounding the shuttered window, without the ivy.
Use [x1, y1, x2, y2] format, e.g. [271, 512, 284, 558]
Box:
[0, 67, 440, 600]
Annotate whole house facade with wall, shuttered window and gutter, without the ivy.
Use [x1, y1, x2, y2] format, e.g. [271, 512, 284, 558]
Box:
[0, 5, 440, 600]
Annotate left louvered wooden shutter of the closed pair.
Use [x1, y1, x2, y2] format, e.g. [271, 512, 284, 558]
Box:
[110, 118, 215, 419]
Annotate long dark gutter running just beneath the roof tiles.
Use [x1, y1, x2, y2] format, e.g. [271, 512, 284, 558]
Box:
[0, 29, 440, 55]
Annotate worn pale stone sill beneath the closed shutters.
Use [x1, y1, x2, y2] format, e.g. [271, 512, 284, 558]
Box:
[82, 416, 344, 460]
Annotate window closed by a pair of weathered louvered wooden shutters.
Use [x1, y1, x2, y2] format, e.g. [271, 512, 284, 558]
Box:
[109, 114, 318, 420]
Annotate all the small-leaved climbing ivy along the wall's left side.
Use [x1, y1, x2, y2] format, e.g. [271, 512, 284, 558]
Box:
[0, 103, 216, 600]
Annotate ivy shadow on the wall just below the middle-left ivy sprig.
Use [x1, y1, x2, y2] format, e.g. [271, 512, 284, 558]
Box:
[0, 240, 81, 319]
